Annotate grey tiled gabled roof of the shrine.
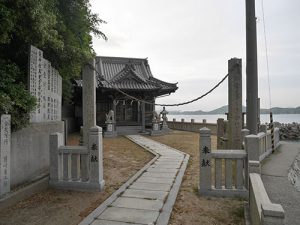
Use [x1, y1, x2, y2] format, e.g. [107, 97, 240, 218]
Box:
[76, 56, 178, 96]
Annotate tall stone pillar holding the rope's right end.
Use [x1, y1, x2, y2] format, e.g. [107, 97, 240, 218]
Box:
[228, 58, 242, 149]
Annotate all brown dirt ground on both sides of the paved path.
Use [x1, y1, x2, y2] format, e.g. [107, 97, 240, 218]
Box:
[0, 131, 244, 225]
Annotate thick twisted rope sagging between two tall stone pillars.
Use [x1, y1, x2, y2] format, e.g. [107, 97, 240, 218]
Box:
[88, 64, 228, 107]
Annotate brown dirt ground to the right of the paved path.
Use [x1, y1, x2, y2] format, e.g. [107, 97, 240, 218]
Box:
[151, 131, 245, 225]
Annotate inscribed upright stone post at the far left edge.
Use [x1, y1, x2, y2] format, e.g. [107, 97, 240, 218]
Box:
[0, 114, 11, 196]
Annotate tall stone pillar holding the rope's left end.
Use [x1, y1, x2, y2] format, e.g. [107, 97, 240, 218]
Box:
[82, 59, 96, 145]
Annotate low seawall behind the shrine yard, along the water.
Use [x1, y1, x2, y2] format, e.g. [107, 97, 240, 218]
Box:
[168, 121, 217, 135]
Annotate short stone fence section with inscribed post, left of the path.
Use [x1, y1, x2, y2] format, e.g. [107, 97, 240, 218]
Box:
[49, 127, 105, 191]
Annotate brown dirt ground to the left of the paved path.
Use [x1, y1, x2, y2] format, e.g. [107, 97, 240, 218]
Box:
[0, 135, 153, 225]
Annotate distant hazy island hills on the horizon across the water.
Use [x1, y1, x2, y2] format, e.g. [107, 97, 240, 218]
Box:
[169, 105, 300, 115]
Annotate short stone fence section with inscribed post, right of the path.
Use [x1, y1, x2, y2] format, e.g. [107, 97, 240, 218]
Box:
[199, 128, 248, 199]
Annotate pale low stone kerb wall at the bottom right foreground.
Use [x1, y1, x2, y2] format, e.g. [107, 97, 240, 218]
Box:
[249, 173, 285, 225]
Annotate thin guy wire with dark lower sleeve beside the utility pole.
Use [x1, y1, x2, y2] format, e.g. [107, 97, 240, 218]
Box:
[261, 0, 275, 152]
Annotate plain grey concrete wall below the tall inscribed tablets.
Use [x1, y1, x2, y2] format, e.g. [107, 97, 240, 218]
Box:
[11, 121, 64, 187]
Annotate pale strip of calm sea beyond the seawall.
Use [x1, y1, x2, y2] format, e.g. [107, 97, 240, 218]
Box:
[167, 114, 300, 124]
